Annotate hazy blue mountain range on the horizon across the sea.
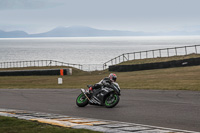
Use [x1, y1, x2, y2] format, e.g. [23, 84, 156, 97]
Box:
[0, 26, 200, 38]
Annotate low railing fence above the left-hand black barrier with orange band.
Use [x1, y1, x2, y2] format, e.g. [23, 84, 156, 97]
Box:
[0, 60, 83, 70]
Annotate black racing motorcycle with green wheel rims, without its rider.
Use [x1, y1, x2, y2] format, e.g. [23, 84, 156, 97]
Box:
[76, 83, 121, 108]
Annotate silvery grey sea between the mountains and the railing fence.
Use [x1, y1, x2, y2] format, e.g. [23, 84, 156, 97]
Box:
[0, 36, 200, 70]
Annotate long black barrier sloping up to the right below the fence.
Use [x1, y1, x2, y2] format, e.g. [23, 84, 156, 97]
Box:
[109, 58, 200, 72]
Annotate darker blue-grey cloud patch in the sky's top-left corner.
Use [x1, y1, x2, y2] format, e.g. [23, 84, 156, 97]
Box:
[0, 0, 63, 10]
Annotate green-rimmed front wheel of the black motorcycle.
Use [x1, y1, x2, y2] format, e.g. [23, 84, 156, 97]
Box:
[105, 94, 119, 108]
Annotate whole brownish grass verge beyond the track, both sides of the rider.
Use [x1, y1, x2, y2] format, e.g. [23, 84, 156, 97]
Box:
[0, 55, 200, 91]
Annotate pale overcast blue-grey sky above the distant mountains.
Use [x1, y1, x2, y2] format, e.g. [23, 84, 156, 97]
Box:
[0, 0, 200, 33]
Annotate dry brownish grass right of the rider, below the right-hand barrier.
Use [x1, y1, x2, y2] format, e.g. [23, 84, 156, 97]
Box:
[117, 66, 200, 90]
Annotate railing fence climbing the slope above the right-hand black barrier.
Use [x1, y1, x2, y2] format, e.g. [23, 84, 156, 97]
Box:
[103, 45, 200, 69]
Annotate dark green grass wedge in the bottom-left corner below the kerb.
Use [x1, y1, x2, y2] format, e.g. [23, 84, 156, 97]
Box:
[0, 116, 100, 133]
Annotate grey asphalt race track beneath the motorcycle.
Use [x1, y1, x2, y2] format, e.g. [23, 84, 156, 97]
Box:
[0, 89, 200, 132]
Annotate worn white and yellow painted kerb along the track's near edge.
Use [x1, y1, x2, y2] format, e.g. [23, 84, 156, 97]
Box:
[0, 108, 197, 133]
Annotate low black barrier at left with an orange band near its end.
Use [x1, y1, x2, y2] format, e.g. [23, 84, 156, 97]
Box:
[0, 68, 72, 76]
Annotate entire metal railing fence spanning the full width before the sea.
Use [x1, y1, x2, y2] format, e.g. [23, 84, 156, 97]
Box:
[0, 45, 200, 71]
